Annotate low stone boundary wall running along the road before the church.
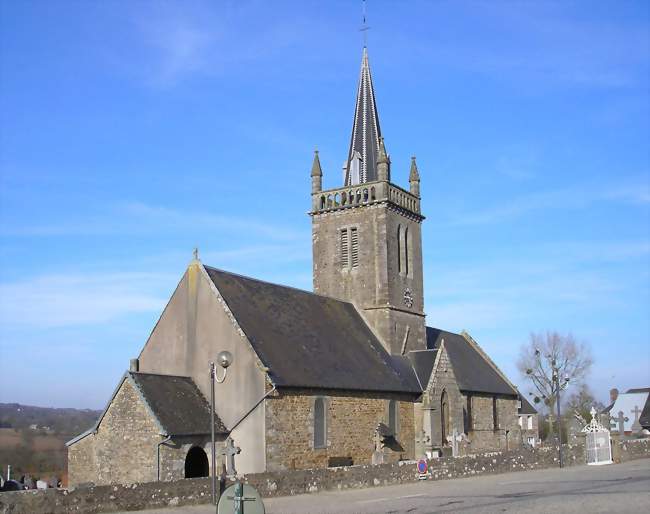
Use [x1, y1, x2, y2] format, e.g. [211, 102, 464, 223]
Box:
[0, 439, 650, 514]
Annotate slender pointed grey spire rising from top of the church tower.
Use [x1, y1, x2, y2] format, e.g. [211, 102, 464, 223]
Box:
[345, 46, 381, 185]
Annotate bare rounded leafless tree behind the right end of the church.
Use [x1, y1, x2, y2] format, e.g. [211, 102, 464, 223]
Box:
[517, 332, 593, 412]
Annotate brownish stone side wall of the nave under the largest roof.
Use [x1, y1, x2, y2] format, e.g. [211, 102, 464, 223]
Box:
[266, 390, 415, 471]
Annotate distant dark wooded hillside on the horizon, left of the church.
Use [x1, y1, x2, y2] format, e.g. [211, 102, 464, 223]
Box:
[0, 403, 101, 435]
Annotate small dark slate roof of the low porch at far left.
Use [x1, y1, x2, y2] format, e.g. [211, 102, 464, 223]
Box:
[129, 372, 228, 435]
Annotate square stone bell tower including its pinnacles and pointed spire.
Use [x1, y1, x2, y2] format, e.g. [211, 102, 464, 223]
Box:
[309, 47, 426, 355]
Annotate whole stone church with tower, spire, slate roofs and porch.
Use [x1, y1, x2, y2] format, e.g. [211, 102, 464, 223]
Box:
[68, 48, 522, 485]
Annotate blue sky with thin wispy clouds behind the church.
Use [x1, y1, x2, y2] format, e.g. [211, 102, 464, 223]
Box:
[0, 0, 650, 408]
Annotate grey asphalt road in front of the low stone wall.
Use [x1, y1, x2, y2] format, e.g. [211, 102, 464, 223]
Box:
[123, 459, 650, 514]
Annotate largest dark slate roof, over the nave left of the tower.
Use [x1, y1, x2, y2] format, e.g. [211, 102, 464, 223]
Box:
[205, 266, 422, 395]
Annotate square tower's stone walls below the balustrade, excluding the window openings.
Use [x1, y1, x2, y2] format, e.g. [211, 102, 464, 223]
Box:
[312, 196, 426, 354]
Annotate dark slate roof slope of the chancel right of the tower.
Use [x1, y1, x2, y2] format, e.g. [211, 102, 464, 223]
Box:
[427, 327, 518, 396]
